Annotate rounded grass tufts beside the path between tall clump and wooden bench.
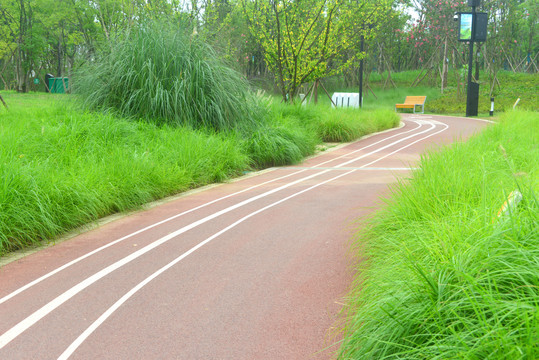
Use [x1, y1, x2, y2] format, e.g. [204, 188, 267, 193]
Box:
[244, 99, 400, 168]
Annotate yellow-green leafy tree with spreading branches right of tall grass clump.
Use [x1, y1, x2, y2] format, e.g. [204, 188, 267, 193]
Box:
[242, 0, 390, 102]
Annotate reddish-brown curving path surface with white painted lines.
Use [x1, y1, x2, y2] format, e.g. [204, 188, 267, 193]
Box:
[0, 114, 487, 360]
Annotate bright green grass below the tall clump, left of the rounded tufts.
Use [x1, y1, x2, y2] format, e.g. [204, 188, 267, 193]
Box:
[0, 94, 250, 254]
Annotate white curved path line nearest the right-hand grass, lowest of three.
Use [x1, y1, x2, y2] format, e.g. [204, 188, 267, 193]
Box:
[58, 120, 449, 360]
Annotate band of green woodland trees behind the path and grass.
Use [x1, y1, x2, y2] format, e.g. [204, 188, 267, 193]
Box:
[0, 0, 539, 100]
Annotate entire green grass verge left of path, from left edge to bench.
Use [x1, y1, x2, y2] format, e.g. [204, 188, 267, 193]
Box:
[0, 92, 398, 255]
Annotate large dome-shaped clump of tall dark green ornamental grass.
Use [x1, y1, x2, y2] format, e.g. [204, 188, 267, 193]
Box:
[74, 23, 258, 130]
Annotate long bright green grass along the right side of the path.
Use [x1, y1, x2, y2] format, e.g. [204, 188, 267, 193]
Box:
[339, 111, 539, 359]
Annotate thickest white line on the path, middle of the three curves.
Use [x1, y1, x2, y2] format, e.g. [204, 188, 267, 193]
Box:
[0, 121, 434, 349]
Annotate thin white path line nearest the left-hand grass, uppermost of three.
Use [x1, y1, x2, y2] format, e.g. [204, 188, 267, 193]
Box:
[0, 124, 422, 304]
